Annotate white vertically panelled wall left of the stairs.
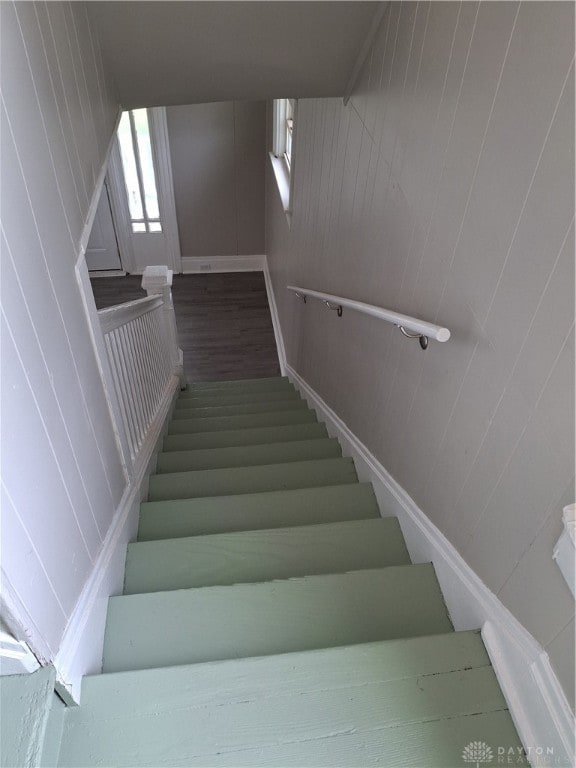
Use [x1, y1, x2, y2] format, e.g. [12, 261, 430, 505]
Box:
[0, 2, 125, 658]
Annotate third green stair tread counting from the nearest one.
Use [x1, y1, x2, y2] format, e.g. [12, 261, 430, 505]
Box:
[124, 517, 410, 594]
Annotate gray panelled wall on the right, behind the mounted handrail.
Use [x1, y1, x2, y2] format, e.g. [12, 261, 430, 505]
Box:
[266, 2, 574, 702]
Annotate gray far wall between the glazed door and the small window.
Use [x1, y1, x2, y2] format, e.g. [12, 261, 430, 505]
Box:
[166, 101, 266, 256]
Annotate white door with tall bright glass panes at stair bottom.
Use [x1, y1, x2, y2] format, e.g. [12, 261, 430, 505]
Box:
[110, 107, 181, 273]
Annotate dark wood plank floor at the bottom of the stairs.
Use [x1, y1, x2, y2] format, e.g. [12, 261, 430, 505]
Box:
[91, 272, 280, 382]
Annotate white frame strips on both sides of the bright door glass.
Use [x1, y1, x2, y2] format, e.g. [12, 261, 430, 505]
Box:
[107, 107, 182, 274]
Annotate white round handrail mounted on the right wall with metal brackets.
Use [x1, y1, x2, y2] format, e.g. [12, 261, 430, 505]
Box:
[287, 285, 450, 349]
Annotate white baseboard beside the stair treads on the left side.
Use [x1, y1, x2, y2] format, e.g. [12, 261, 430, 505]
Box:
[53, 376, 180, 705]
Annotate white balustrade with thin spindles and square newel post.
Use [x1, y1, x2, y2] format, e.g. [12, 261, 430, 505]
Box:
[98, 267, 183, 466]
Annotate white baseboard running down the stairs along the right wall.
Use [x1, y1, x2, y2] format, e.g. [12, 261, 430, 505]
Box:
[286, 364, 576, 766]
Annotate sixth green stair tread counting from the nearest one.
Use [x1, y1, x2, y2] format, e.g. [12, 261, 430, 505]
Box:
[156, 437, 342, 473]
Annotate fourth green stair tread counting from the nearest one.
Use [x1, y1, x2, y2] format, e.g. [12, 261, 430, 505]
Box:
[138, 483, 380, 541]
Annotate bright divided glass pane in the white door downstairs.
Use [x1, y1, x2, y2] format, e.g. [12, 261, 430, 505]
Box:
[118, 109, 162, 234]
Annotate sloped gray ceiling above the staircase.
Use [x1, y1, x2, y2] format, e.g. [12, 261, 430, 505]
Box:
[87, 0, 380, 109]
